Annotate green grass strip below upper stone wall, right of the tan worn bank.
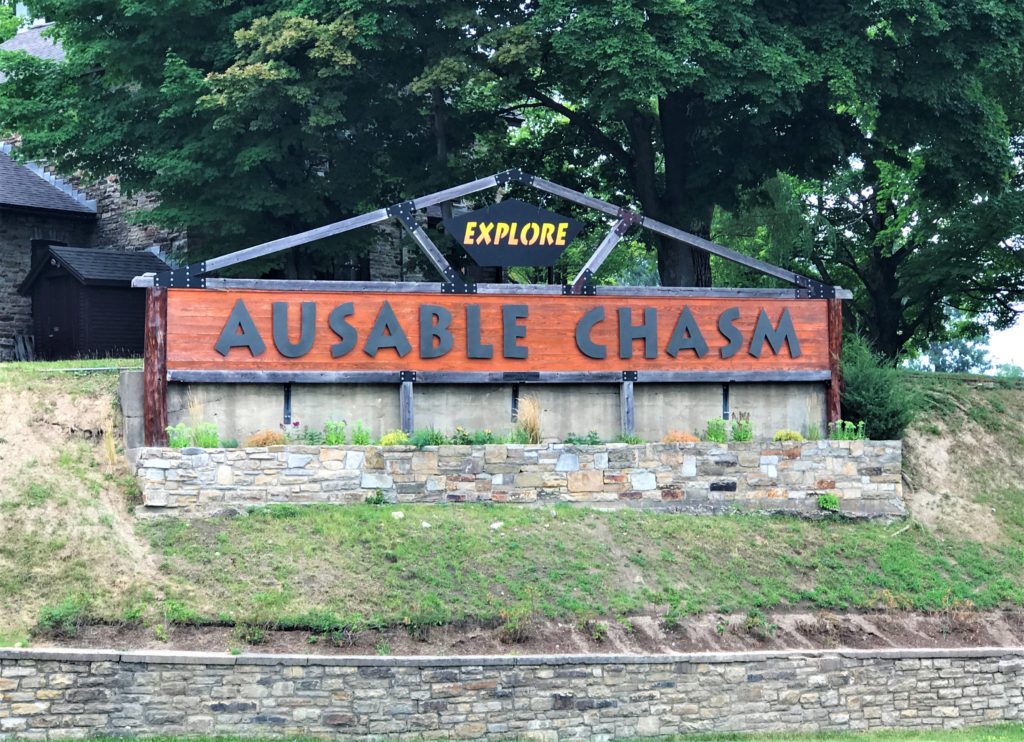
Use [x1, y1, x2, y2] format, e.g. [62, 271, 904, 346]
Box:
[140, 496, 1024, 627]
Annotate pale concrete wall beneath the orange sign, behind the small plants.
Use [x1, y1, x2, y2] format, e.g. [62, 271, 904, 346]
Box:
[121, 372, 825, 448]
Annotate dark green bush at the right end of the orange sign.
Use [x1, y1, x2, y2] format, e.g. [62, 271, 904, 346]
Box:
[842, 335, 922, 440]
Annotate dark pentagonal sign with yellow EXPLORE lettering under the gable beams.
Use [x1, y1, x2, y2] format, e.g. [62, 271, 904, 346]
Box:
[444, 199, 583, 267]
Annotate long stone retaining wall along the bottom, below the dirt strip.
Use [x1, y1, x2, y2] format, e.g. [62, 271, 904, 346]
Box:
[0, 648, 1024, 741]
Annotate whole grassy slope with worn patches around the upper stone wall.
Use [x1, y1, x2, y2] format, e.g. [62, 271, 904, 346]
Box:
[0, 362, 1024, 643]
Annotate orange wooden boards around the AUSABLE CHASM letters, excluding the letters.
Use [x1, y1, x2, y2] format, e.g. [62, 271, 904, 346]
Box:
[167, 289, 830, 373]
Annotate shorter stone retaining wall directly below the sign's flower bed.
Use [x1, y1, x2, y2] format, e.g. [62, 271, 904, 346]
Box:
[136, 441, 904, 516]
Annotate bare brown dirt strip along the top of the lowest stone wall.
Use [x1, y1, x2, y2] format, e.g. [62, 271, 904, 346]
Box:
[49, 611, 1024, 656]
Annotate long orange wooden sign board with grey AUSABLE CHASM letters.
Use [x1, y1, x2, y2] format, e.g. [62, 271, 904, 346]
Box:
[166, 289, 829, 374]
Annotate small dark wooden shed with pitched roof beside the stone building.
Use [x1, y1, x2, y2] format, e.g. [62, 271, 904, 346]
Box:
[18, 245, 168, 360]
